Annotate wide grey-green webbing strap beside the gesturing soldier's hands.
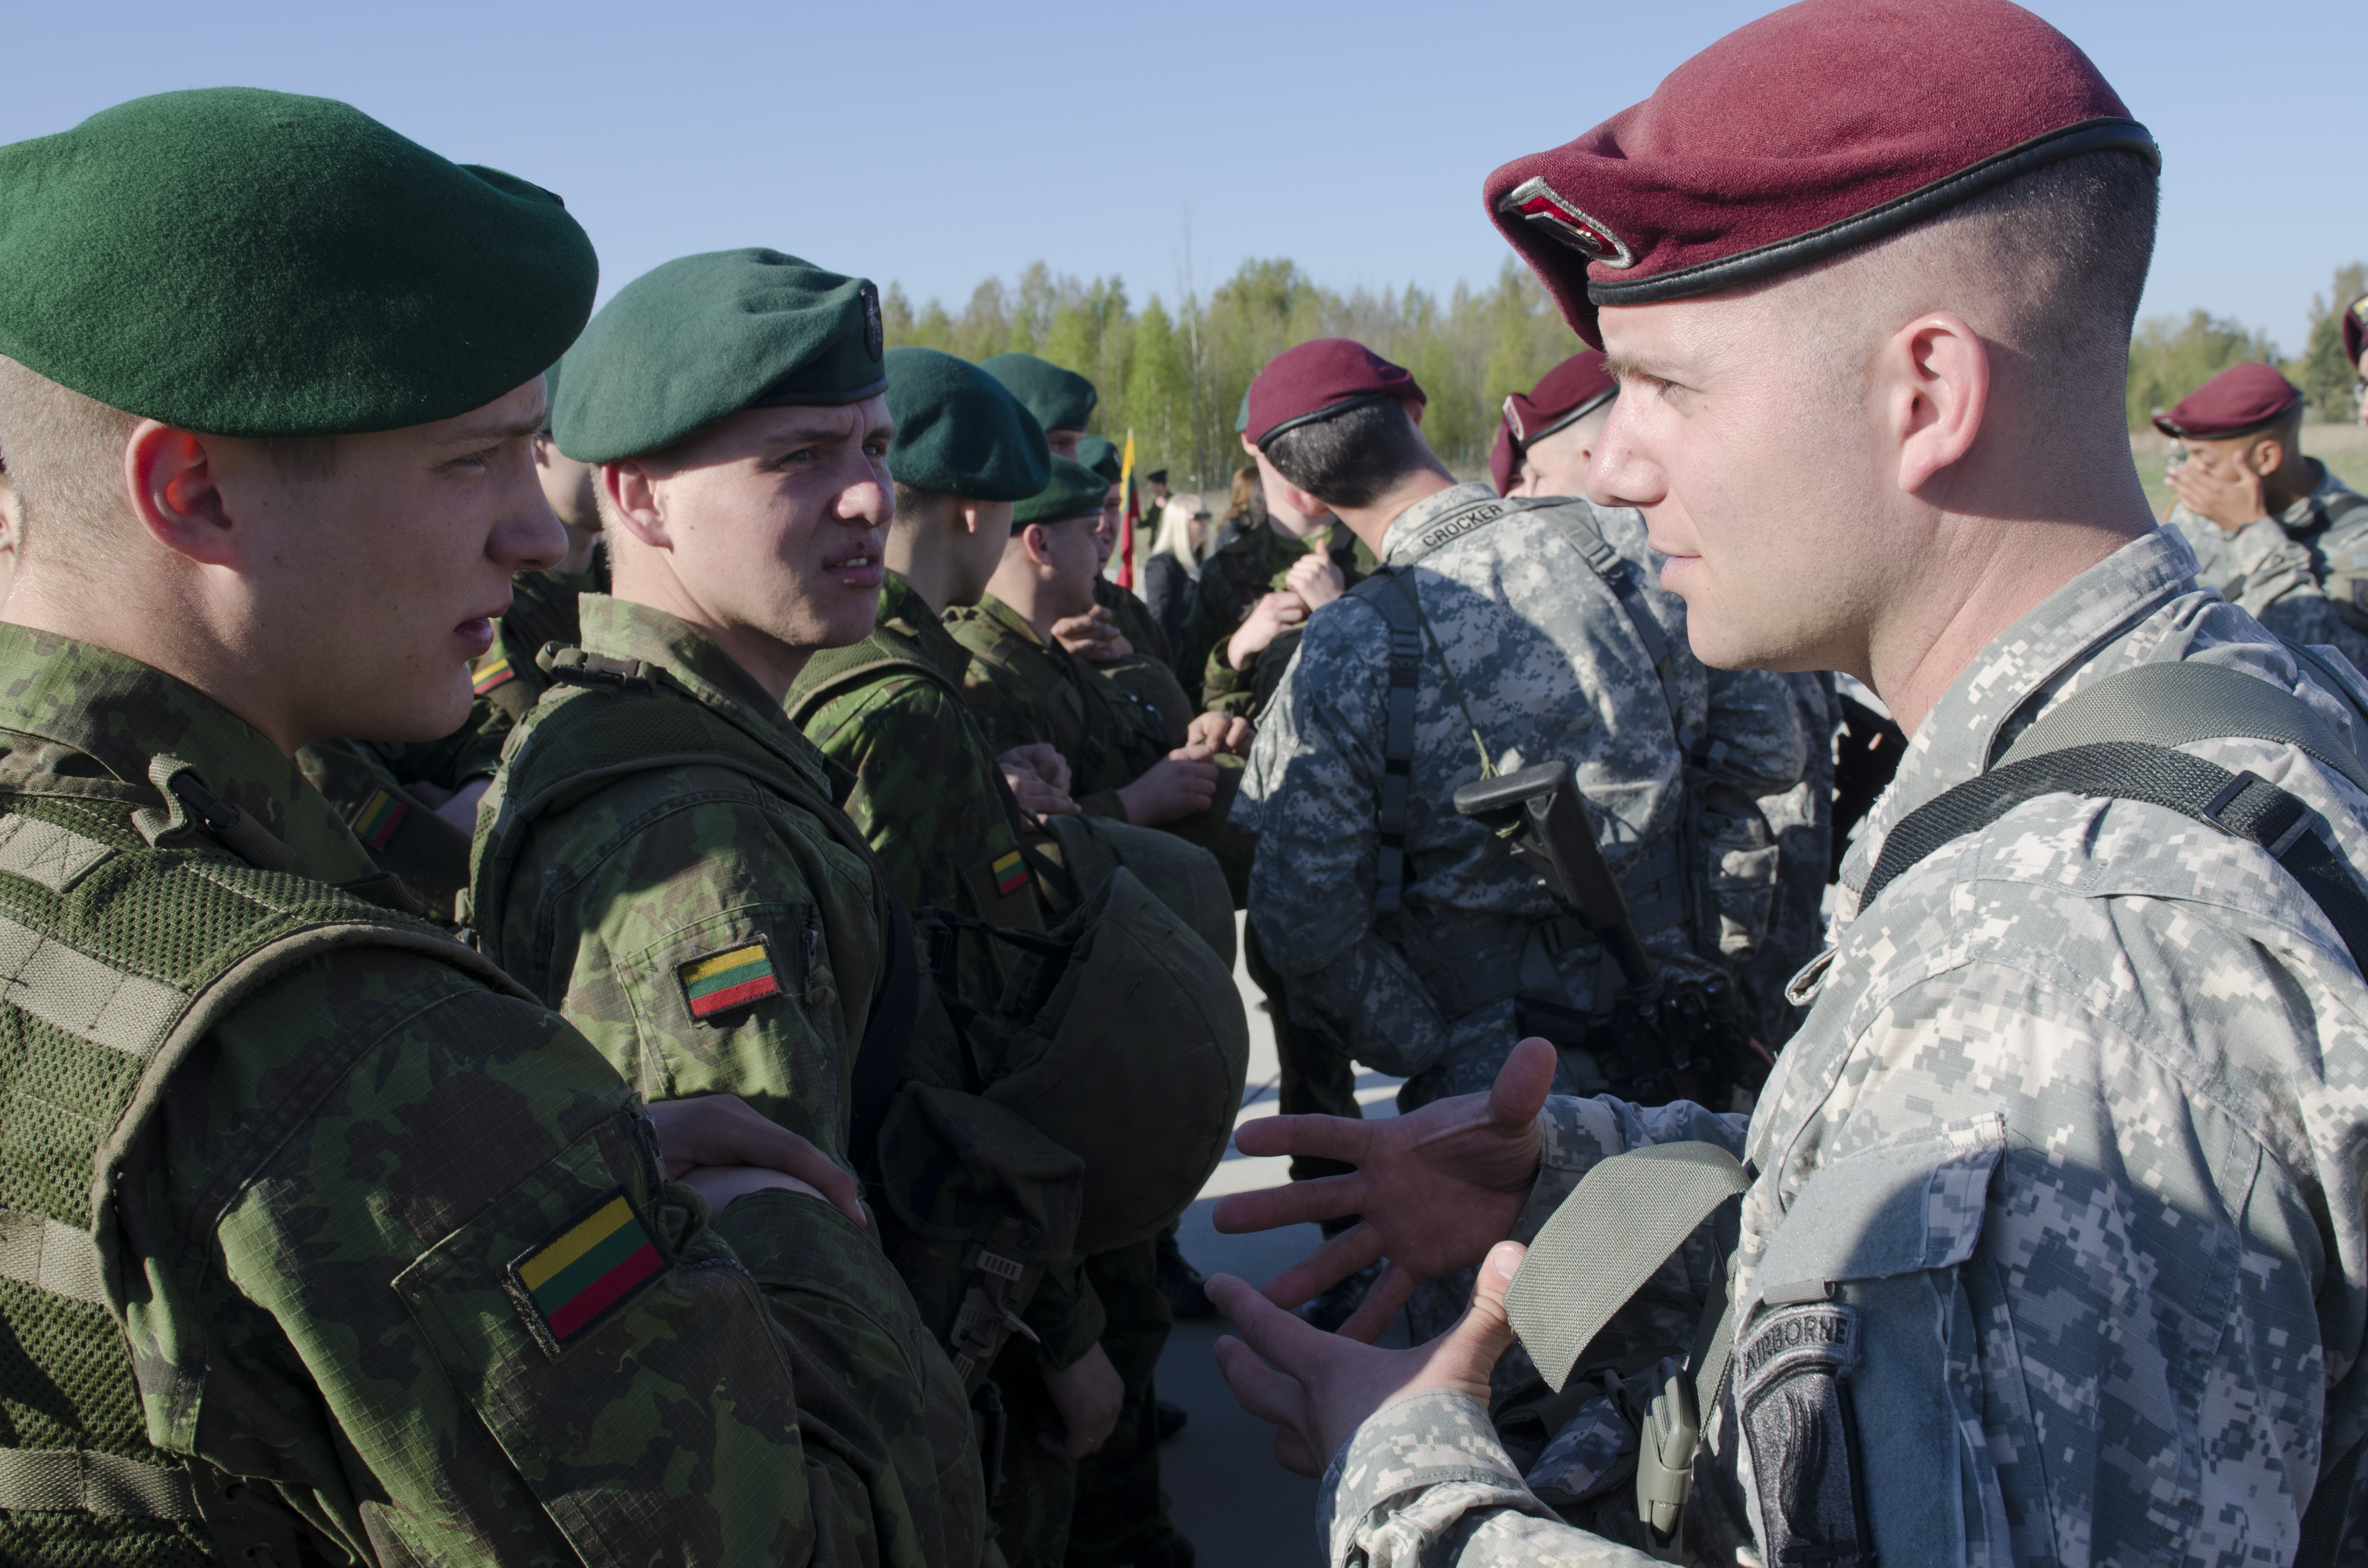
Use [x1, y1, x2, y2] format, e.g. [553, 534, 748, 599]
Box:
[1504, 1144, 1750, 1393]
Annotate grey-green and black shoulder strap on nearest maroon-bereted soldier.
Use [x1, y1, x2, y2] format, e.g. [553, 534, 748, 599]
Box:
[1859, 663, 2368, 973]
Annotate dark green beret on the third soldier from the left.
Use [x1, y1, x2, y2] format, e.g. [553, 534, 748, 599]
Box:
[888, 348, 1051, 500]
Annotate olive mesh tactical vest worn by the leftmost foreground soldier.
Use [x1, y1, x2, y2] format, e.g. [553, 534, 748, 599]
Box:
[0, 756, 523, 1566]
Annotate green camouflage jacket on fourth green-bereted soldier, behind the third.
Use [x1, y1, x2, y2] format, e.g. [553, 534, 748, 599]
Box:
[945, 595, 1184, 820]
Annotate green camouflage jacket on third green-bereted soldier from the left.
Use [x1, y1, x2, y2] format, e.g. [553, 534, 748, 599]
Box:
[789, 571, 1044, 1009]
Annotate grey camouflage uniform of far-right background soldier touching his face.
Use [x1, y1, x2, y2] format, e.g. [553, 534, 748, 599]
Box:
[2164, 457, 2368, 670]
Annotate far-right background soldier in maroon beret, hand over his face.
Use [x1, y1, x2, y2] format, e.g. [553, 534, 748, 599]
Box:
[2155, 365, 2368, 668]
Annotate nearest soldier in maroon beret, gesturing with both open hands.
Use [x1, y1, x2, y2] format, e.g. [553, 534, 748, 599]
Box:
[1210, 0, 2368, 1568]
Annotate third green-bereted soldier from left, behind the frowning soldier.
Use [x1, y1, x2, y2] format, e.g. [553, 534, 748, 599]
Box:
[789, 348, 1122, 1568]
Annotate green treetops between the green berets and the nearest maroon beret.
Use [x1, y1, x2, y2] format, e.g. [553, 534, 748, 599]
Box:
[883, 258, 1579, 490]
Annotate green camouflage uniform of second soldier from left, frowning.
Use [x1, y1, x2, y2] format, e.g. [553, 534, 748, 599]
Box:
[471, 595, 985, 1563]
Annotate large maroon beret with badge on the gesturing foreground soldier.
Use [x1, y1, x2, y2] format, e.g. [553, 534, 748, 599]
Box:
[1485, 0, 2162, 343]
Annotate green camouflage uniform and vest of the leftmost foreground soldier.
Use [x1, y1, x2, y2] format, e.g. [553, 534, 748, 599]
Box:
[0, 625, 980, 1566]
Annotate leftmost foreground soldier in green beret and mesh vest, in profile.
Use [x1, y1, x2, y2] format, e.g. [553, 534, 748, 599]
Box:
[0, 87, 978, 1563]
